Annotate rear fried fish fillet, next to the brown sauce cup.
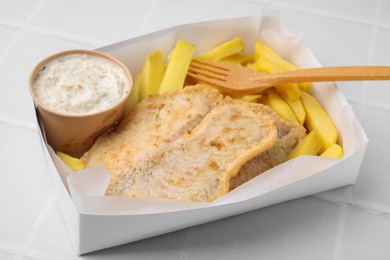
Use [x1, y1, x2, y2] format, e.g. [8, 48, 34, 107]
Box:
[81, 85, 223, 176]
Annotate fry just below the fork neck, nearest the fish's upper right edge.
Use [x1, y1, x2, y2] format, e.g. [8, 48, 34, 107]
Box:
[260, 88, 298, 122]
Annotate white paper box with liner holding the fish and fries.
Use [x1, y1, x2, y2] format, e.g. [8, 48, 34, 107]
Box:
[32, 14, 368, 254]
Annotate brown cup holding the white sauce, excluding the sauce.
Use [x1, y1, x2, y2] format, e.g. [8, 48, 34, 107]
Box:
[29, 50, 133, 158]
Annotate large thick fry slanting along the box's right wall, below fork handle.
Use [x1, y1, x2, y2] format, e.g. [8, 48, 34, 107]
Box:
[301, 91, 338, 152]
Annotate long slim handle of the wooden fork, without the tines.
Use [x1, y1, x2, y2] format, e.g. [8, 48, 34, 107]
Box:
[259, 66, 390, 84]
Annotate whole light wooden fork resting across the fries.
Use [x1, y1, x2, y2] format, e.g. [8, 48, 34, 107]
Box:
[187, 59, 390, 95]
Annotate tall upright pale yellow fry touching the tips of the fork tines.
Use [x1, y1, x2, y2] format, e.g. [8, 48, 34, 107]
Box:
[158, 40, 195, 94]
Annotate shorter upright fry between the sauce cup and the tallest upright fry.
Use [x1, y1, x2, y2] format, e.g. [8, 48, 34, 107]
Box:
[139, 51, 165, 100]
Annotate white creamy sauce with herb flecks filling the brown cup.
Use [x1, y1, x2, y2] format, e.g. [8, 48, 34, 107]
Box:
[33, 54, 129, 115]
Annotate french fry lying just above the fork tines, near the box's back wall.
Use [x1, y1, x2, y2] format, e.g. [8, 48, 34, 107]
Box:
[198, 38, 244, 61]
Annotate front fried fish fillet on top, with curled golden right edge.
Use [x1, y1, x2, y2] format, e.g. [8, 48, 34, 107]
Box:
[106, 97, 277, 201]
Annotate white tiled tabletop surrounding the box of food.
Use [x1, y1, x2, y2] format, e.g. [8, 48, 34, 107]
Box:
[0, 0, 390, 259]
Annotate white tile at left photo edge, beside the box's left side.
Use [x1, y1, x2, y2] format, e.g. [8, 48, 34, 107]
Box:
[0, 122, 53, 246]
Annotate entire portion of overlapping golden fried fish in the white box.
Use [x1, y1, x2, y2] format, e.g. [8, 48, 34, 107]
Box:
[81, 85, 305, 201]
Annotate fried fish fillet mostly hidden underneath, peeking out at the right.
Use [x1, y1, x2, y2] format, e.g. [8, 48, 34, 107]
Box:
[230, 104, 306, 190]
